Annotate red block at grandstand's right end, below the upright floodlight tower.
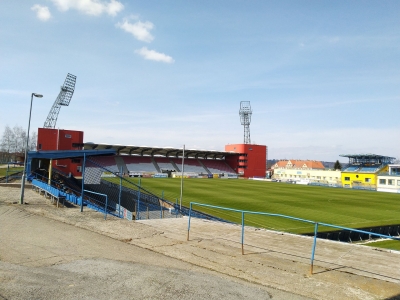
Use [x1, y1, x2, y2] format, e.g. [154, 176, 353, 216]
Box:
[225, 144, 267, 178]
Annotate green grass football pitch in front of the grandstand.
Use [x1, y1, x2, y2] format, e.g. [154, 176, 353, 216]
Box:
[113, 178, 400, 237]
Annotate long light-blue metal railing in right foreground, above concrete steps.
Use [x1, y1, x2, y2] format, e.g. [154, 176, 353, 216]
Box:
[187, 202, 400, 274]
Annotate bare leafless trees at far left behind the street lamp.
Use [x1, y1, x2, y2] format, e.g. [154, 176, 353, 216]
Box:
[0, 125, 37, 162]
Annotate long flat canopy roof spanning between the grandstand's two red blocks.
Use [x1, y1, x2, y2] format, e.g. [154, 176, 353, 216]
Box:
[83, 143, 245, 159]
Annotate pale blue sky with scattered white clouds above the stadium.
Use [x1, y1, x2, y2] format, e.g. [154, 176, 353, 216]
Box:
[0, 0, 400, 162]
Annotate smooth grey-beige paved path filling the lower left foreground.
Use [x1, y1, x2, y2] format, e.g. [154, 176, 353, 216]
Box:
[0, 189, 307, 300]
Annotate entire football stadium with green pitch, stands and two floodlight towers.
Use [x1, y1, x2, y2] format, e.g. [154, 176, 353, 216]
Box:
[14, 86, 400, 249]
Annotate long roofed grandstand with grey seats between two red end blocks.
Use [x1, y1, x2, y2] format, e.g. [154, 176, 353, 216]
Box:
[32, 128, 267, 178]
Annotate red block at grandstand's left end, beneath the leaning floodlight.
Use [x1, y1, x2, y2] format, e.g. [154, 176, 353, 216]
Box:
[37, 128, 83, 176]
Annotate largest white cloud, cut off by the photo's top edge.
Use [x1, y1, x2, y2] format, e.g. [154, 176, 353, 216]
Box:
[51, 0, 124, 16]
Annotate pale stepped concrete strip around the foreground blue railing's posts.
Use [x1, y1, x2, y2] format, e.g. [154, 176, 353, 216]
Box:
[132, 218, 400, 299]
